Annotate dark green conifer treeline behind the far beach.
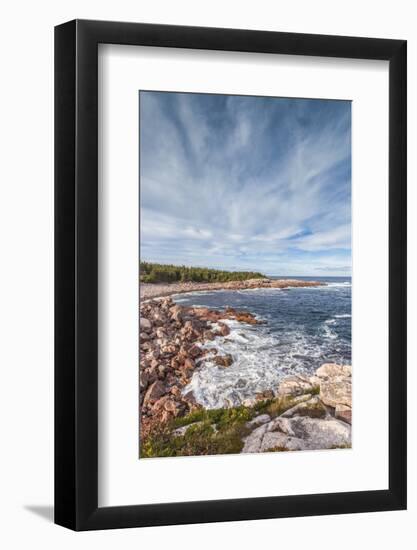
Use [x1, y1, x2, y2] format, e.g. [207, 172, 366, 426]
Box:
[140, 262, 265, 283]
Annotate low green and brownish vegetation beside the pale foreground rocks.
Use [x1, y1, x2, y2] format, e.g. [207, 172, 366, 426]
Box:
[140, 397, 300, 458]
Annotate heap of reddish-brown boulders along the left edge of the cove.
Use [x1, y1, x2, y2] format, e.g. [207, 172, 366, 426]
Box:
[139, 298, 258, 438]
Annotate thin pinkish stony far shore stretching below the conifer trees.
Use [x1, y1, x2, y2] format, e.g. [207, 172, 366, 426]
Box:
[140, 278, 326, 300]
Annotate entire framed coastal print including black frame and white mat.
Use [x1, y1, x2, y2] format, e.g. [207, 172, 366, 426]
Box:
[55, 20, 406, 530]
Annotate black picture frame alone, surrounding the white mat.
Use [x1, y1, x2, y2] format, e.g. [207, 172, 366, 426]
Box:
[55, 20, 407, 531]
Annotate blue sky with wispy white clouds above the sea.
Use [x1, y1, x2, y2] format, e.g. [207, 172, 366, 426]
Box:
[140, 92, 351, 276]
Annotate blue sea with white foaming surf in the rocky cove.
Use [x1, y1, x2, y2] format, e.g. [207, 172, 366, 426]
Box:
[173, 277, 351, 408]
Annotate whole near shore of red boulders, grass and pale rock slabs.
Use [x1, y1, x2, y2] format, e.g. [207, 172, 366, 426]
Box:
[139, 298, 352, 456]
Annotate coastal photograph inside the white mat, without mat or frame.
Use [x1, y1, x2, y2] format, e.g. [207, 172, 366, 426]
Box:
[139, 91, 352, 458]
